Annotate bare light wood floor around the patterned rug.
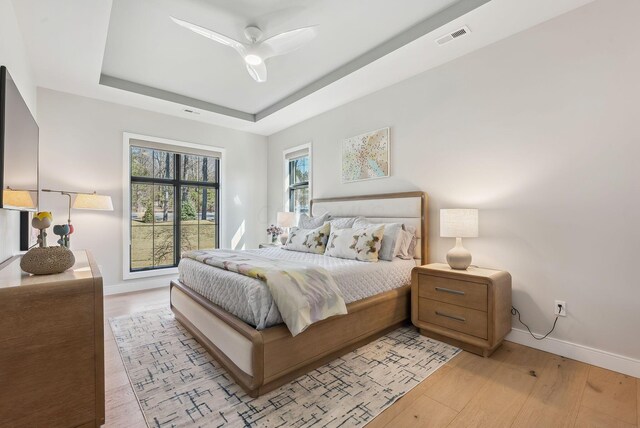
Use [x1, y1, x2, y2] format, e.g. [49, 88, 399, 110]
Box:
[105, 288, 640, 428]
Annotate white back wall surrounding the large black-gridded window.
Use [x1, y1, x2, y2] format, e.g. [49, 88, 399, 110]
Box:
[38, 89, 267, 290]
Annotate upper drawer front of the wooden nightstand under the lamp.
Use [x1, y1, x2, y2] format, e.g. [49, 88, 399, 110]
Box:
[418, 274, 487, 312]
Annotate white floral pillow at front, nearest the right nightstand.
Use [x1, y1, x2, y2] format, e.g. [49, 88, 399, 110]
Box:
[324, 225, 384, 262]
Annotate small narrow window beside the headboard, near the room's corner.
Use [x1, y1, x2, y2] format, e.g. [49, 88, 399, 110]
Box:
[285, 145, 311, 214]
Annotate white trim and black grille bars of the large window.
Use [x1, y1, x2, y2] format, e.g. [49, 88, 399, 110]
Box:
[122, 132, 225, 281]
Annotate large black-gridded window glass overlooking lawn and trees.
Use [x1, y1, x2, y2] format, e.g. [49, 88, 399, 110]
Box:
[128, 144, 220, 272]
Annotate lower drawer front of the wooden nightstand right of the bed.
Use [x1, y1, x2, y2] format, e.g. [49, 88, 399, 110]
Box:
[418, 298, 487, 339]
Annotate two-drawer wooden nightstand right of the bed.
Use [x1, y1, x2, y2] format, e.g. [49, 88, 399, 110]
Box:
[411, 263, 511, 357]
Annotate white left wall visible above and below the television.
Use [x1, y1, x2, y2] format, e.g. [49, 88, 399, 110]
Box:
[0, 0, 36, 262]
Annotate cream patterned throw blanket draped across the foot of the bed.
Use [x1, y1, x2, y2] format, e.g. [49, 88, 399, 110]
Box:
[182, 250, 347, 336]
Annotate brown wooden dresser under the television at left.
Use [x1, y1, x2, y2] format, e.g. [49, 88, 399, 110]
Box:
[0, 251, 104, 427]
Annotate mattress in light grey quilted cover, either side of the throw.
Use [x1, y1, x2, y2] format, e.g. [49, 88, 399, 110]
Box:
[178, 247, 416, 330]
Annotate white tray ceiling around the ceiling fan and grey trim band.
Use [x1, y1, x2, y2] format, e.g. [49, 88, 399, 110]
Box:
[13, 0, 592, 135]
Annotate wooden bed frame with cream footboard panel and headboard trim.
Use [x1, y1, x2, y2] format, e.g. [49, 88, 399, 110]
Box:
[171, 192, 428, 397]
